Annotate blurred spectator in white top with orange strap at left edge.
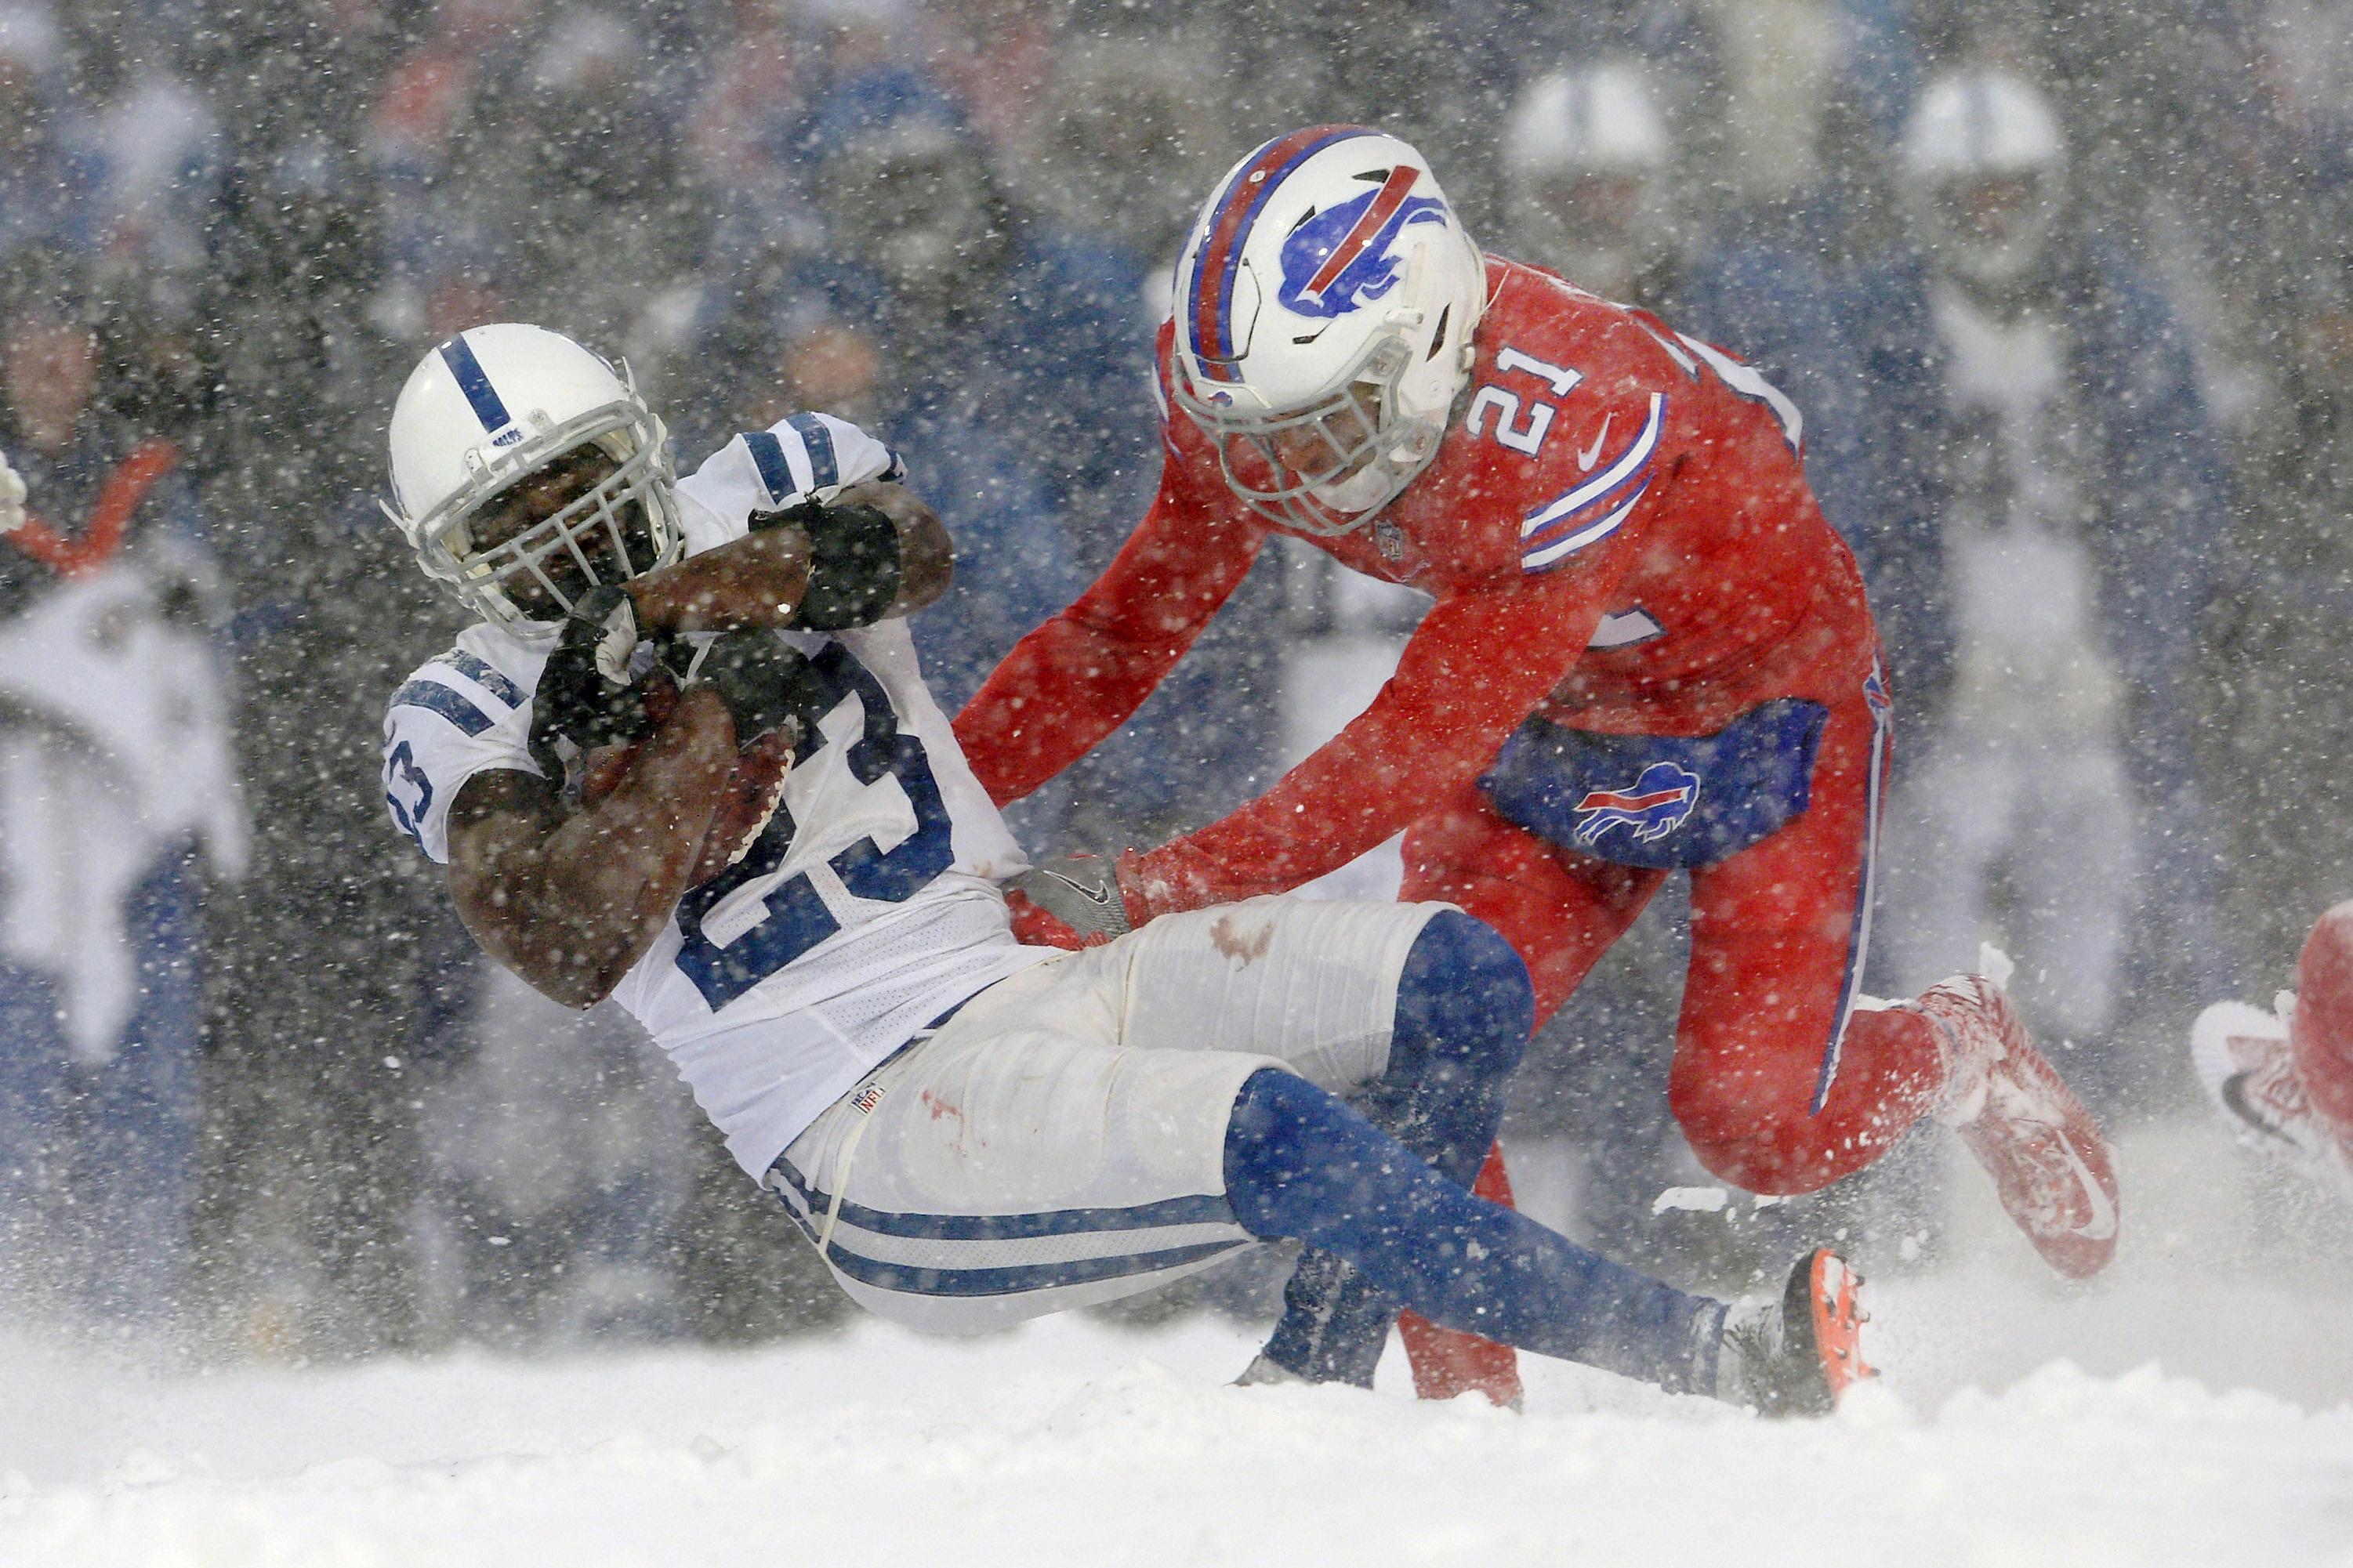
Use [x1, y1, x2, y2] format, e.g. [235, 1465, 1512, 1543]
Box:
[0, 252, 247, 1331]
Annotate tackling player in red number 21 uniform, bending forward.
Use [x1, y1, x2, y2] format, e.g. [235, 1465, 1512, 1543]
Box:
[955, 125, 2118, 1394]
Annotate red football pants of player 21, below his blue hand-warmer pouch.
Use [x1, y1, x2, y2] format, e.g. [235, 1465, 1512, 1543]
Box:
[1402, 689, 1944, 1194]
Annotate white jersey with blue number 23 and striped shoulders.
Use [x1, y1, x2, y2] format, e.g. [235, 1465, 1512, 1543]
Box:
[383, 414, 1052, 1180]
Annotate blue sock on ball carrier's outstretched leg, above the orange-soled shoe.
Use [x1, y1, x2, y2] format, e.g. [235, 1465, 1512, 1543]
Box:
[1226, 1067, 1724, 1394]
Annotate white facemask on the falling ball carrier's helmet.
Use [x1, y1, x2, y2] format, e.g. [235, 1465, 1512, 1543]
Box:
[386, 402, 685, 623]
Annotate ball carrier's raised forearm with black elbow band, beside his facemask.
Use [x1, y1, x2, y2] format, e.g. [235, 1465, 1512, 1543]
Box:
[629, 480, 955, 632]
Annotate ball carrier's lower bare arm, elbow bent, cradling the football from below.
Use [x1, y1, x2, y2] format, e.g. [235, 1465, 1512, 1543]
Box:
[449, 686, 737, 1009]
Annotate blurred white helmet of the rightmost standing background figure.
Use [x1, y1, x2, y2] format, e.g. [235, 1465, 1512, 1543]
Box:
[1902, 66, 2066, 289]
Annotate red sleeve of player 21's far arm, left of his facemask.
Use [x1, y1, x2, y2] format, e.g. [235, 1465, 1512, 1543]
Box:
[955, 454, 1266, 806]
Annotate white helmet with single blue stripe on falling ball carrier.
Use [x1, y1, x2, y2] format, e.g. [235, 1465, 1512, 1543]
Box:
[383, 322, 685, 623]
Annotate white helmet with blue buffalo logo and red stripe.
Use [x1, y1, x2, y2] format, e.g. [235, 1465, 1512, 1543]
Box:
[1174, 125, 1487, 536]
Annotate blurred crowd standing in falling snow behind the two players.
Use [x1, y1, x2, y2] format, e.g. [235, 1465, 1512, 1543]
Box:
[0, 0, 2353, 1356]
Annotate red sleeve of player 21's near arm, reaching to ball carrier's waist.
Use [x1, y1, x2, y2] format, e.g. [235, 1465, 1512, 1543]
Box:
[1122, 552, 1635, 914]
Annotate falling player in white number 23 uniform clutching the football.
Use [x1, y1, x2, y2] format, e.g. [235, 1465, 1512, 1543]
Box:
[383, 324, 1866, 1413]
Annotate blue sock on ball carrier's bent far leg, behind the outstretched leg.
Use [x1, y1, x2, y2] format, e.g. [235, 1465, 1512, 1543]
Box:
[1266, 910, 1536, 1387]
